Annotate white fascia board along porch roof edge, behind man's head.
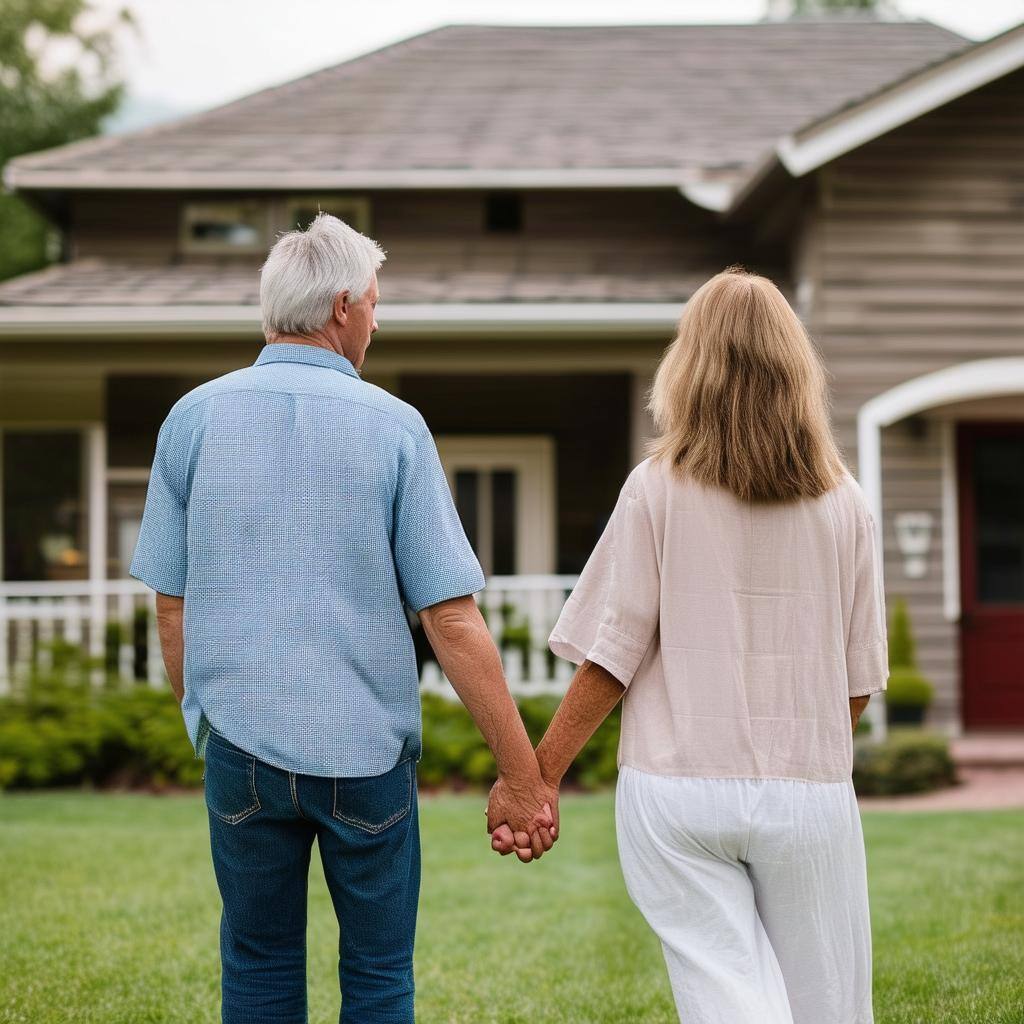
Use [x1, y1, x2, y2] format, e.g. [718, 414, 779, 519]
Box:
[0, 302, 683, 340]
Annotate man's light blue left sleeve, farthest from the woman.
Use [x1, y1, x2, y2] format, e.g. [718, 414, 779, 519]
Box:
[128, 420, 188, 597]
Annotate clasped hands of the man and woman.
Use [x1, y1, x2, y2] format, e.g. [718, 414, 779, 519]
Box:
[486, 770, 558, 863]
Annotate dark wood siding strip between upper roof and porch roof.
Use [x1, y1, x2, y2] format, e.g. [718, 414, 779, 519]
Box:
[69, 189, 783, 284]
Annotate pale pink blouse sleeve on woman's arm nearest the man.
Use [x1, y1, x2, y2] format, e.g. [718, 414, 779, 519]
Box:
[548, 478, 662, 686]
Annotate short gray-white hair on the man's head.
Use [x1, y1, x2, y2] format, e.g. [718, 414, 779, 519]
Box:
[259, 213, 386, 338]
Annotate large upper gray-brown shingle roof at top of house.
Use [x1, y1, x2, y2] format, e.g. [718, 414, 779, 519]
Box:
[10, 17, 967, 187]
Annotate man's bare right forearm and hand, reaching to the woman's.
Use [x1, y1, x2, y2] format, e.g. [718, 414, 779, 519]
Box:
[420, 596, 558, 860]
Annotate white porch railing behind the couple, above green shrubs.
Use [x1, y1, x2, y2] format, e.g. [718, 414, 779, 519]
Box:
[0, 575, 577, 699]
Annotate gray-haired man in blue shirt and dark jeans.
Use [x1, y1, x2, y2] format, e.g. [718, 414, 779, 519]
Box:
[131, 214, 557, 1024]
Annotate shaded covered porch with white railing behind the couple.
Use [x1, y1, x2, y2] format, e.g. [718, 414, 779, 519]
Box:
[0, 309, 672, 693]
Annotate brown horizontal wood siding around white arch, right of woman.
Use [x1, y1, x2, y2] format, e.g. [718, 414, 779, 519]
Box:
[798, 73, 1024, 725]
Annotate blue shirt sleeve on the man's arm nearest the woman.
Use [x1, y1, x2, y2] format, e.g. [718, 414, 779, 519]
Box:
[392, 431, 484, 611]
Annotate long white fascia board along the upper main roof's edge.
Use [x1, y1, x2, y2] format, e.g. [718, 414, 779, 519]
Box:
[3, 160, 687, 191]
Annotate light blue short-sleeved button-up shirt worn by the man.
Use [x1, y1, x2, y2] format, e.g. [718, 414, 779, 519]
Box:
[130, 343, 483, 776]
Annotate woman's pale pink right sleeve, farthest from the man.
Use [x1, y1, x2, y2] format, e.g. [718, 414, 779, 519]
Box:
[846, 508, 889, 697]
